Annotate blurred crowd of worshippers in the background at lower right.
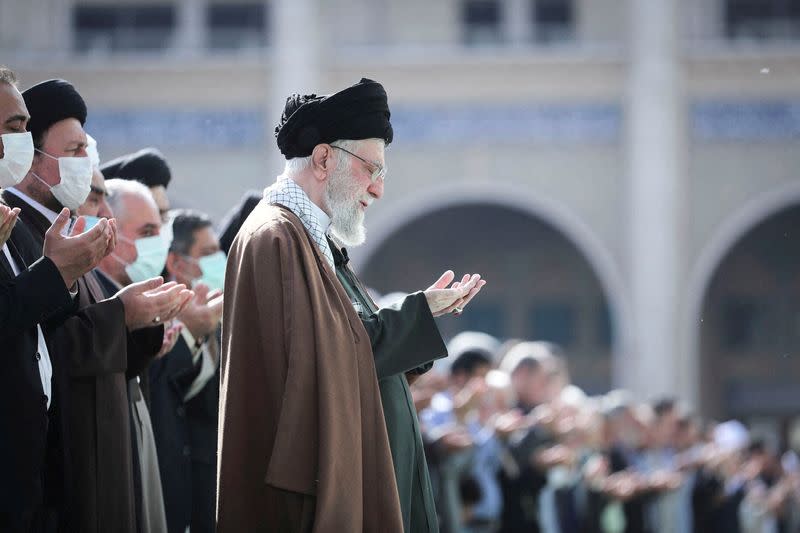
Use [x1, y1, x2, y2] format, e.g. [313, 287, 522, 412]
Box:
[411, 332, 800, 533]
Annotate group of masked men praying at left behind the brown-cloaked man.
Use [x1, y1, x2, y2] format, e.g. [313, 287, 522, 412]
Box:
[0, 68, 234, 533]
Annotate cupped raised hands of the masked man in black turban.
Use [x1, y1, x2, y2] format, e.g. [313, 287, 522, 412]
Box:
[115, 277, 194, 331]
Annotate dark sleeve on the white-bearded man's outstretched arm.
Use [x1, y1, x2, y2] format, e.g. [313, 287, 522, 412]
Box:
[361, 292, 447, 379]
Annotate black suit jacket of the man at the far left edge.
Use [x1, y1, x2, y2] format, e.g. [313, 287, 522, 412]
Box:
[0, 203, 77, 531]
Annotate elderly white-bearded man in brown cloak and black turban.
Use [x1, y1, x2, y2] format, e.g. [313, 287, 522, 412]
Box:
[217, 79, 485, 533]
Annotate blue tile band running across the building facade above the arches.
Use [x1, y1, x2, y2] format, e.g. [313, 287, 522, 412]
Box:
[86, 101, 800, 149]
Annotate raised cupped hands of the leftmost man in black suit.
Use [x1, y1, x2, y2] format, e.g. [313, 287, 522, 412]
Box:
[43, 207, 116, 287]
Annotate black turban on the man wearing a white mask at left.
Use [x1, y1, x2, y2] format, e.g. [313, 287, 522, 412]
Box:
[22, 80, 86, 145]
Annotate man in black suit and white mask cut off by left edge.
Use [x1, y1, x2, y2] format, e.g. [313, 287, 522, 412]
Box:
[0, 68, 112, 531]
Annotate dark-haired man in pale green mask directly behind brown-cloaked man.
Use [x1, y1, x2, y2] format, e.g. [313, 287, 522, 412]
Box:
[149, 210, 225, 533]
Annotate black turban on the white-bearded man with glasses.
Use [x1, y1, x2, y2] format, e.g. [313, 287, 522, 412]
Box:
[275, 78, 393, 159]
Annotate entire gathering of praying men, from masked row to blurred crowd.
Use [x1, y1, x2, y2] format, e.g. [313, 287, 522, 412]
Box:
[0, 68, 800, 533]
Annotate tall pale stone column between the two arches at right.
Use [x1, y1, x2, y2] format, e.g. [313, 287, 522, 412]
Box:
[615, 0, 696, 403]
